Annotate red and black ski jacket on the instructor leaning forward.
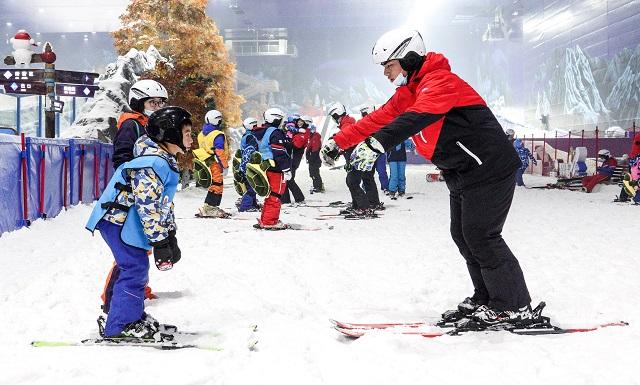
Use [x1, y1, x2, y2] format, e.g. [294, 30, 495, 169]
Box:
[334, 52, 520, 186]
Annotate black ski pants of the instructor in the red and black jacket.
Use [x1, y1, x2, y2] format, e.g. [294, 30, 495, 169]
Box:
[445, 172, 531, 310]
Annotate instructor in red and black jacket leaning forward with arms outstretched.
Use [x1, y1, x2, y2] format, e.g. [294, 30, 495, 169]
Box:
[322, 30, 534, 325]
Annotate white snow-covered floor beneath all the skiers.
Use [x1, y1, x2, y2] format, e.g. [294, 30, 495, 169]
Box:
[0, 164, 640, 385]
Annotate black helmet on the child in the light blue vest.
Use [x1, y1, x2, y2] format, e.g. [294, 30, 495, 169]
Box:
[147, 106, 193, 151]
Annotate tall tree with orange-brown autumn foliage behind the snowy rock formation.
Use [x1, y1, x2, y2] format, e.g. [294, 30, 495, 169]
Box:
[113, 0, 244, 129]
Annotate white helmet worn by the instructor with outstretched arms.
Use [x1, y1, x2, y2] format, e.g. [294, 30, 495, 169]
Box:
[371, 29, 427, 65]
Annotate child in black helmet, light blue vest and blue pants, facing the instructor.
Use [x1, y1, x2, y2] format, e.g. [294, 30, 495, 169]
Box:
[86, 107, 193, 339]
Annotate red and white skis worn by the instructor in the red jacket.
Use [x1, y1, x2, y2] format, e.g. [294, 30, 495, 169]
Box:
[330, 302, 629, 339]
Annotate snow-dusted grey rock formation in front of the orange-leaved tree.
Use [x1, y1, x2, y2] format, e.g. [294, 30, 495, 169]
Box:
[65, 46, 167, 142]
